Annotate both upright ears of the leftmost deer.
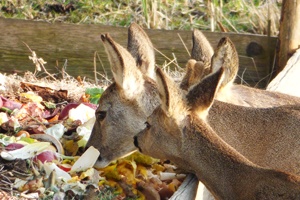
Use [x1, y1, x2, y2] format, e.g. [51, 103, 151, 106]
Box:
[101, 23, 155, 96]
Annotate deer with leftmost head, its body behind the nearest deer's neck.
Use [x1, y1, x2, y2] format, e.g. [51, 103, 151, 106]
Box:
[87, 24, 300, 174]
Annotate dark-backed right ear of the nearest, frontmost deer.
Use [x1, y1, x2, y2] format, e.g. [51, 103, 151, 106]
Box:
[186, 67, 224, 118]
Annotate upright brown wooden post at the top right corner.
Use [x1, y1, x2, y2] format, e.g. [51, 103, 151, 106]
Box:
[274, 0, 300, 75]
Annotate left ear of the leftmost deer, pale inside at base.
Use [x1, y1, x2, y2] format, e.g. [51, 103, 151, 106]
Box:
[101, 34, 144, 97]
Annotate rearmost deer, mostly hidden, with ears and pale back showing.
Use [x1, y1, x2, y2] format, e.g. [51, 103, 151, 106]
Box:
[181, 30, 300, 108]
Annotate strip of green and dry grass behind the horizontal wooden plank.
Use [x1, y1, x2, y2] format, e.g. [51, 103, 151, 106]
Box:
[0, 0, 281, 35]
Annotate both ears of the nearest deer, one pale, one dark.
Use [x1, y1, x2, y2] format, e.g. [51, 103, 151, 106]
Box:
[156, 67, 224, 118]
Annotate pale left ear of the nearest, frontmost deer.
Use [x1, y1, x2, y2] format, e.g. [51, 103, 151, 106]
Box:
[156, 68, 186, 120]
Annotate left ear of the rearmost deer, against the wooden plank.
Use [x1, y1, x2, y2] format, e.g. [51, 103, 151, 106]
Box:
[191, 29, 214, 63]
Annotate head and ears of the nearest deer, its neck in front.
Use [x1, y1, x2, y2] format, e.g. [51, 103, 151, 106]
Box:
[134, 65, 223, 170]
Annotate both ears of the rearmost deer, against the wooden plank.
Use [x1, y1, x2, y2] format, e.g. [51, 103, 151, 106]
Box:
[189, 30, 239, 89]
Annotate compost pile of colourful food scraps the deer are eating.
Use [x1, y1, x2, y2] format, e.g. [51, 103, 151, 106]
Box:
[0, 72, 185, 199]
